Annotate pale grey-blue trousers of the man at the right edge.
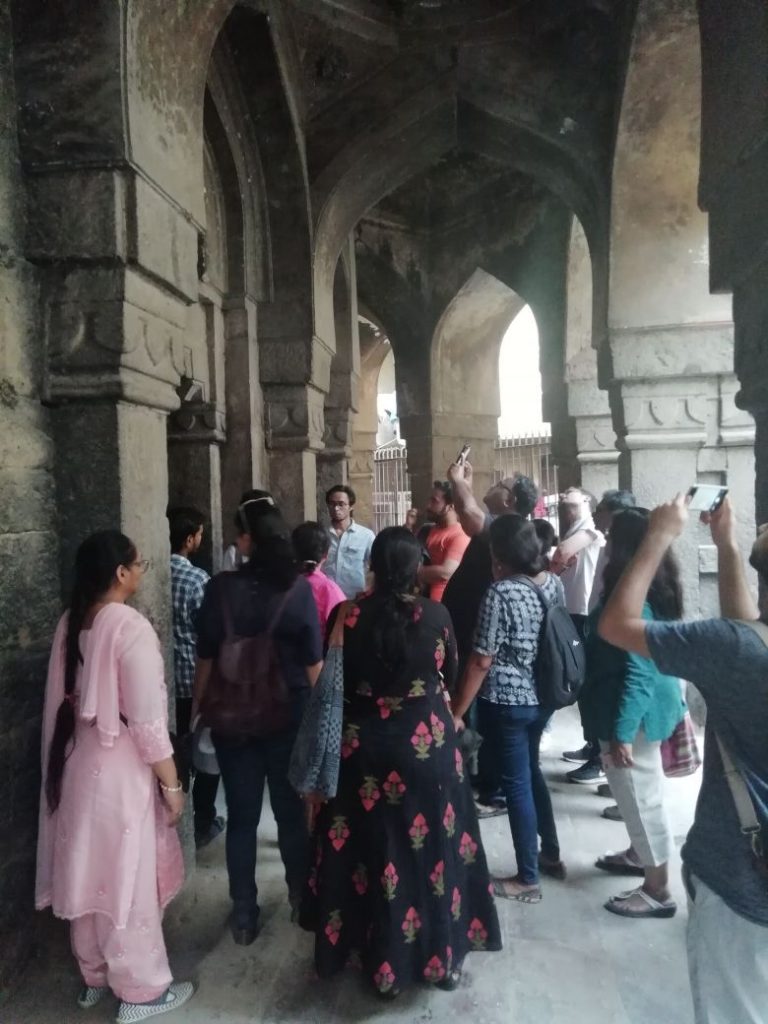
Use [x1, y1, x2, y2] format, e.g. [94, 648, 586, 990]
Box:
[688, 874, 768, 1024]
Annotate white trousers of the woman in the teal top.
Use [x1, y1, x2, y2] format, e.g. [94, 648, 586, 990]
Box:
[600, 729, 672, 867]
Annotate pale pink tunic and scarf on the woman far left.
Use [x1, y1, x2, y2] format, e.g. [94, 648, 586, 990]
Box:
[35, 603, 183, 929]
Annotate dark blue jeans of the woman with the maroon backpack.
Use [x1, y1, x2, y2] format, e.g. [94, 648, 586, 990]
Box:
[213, 729, 309, 913]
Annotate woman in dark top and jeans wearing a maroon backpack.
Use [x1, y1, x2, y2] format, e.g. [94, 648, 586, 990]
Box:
[193, 492, 323, 945]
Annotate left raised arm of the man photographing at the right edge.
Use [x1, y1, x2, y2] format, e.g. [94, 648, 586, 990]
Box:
[597, 495, 688, 657]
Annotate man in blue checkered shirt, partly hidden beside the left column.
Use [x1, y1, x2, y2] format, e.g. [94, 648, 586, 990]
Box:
[168, 508, 224, 849]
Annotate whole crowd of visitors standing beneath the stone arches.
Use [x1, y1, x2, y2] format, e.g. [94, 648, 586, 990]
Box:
[36, 462, 768, 1024]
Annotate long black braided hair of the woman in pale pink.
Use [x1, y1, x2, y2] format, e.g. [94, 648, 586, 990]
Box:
[45, 529, 136, 814]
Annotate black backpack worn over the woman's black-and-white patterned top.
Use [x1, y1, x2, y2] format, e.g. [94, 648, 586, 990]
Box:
[515, 575, 587, 711]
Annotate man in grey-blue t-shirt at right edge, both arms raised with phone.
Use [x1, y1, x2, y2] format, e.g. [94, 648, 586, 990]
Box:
[598, 495, 768, 1024]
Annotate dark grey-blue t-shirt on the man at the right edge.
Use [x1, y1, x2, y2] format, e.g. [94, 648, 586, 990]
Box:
[646, 618, 768, 927]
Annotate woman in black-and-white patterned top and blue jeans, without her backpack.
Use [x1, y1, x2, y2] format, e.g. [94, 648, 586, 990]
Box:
[454, 515, 565, 903]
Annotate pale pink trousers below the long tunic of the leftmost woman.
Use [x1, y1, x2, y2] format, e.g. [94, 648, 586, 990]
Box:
[71, 900, 172, 1002]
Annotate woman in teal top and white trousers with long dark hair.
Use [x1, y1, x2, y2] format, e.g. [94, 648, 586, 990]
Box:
[580, 509, 685, 918]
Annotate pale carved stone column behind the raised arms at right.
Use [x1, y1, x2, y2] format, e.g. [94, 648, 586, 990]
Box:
[611, 324, 755, 614]
